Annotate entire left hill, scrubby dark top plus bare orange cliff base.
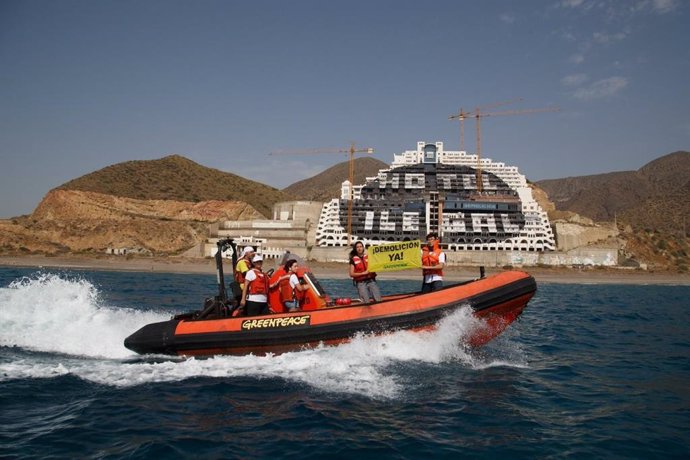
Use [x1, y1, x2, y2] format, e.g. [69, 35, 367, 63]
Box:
[0, 155, 290, 254]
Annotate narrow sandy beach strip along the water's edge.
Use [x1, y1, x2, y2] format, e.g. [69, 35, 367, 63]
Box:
[0, 255, 690, 286]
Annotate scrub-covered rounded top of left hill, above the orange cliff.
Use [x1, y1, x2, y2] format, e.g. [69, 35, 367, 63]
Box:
[57, 155, 290, 217]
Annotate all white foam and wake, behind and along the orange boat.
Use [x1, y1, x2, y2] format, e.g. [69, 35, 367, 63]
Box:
[0, 275, 524, 398]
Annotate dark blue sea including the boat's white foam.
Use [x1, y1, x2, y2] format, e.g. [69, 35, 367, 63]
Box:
[0, 268, 690, 459]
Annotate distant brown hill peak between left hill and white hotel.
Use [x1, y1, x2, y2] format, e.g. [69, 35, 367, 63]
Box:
[283, 158, 388, 201]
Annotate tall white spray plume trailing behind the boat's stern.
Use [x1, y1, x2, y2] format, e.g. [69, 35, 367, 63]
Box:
[0, 274, 168, 358]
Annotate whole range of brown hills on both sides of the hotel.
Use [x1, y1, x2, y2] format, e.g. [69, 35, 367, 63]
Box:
[0, 151, 690, 271]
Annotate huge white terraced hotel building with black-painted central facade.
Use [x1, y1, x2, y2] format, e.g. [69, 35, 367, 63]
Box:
[316, 142, 556, 252]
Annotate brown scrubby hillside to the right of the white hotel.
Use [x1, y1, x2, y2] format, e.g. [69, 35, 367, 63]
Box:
[537, 151, 690, 271]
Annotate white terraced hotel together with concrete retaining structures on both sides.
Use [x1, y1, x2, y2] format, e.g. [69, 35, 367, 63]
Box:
[196, 142, 618, 267]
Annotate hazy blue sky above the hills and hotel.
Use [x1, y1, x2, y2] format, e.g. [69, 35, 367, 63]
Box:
[0, 0, 690, 217]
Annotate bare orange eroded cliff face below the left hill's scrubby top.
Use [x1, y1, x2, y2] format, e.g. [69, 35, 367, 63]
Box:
[0, 189, 262, 254]
